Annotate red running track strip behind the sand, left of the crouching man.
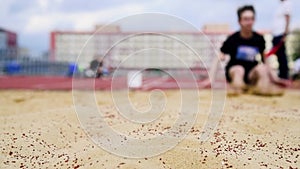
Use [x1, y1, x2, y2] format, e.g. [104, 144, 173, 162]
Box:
[0, 76, 218, 90]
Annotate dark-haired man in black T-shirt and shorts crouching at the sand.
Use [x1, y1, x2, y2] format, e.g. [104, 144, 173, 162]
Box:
[220, 6, 283, 95]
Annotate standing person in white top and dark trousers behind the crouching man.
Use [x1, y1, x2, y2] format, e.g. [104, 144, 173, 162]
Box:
[272, 0, 291, 79]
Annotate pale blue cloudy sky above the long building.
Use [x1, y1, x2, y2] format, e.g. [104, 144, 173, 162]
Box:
[0, 0, 300, 53]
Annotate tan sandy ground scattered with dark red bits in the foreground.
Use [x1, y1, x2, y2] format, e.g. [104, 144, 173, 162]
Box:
[0, 90, 300, 168]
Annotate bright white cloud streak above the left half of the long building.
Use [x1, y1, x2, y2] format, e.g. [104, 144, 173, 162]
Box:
[24, 4, 144, 33]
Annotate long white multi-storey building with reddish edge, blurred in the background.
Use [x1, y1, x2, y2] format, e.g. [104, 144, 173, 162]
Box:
[50, 26, 230, 68]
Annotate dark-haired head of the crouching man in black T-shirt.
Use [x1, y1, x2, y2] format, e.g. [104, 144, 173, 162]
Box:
[237, 5, 255, 31]
